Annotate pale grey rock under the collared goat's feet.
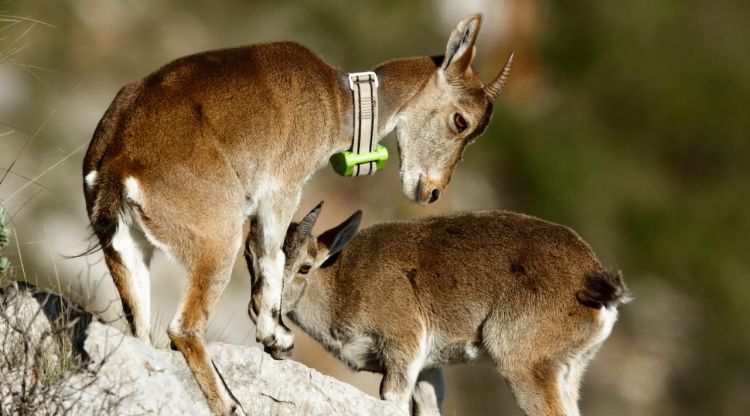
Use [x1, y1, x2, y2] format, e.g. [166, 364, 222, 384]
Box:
[0, 282, 400, 415]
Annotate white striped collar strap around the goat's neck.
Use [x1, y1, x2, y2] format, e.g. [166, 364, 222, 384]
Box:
[349, 72, 378, 176]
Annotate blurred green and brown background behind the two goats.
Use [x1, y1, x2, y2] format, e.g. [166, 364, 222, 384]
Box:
[0, 0, 750, 415]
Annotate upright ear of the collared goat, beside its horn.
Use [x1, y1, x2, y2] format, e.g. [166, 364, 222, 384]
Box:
[441, 14, 482, 77]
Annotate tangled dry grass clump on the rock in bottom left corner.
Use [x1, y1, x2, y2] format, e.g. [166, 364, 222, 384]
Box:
[0, 281, 127, 415]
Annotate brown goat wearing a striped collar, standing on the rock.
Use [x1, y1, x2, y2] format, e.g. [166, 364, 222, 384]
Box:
[83, 15, 510, 415]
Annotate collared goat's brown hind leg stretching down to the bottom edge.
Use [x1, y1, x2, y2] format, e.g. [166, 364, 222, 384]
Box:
[167, 232, 243, 415]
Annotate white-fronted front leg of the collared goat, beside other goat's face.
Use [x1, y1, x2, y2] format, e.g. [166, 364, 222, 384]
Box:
[251, 196, 298, 359]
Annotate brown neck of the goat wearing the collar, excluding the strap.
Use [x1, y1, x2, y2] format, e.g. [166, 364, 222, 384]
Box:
[333, 57, 436, 153]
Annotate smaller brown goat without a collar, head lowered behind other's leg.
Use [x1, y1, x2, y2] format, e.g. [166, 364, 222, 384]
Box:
[246, 203, 627, 416]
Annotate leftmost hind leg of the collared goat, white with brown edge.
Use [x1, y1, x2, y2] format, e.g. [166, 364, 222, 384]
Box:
[102, 220, 154, 345]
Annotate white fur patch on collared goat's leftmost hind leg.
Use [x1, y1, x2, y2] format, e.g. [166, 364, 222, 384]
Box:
[112, 218, 152, 342]
